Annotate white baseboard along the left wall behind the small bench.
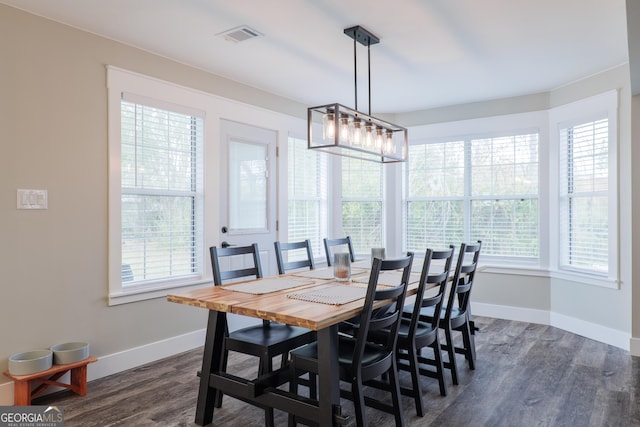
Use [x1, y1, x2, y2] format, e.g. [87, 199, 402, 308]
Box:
[0, 329, 206, 406]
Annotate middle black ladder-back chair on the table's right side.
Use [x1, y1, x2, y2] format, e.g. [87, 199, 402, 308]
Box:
[390, 246, 455, 417]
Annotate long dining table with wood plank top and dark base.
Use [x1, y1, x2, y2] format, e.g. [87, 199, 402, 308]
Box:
[167, 260, 421, 426]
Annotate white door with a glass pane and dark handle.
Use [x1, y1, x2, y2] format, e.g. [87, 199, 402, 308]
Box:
[217, 120, 277, 277]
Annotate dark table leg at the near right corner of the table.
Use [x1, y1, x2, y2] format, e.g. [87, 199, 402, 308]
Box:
[318, 325, 340, 426]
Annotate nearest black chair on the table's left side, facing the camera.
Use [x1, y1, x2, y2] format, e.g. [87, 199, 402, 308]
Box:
[210, 243, 315, 426]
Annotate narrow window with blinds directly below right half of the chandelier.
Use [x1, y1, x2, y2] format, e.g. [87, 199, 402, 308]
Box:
[339, 157, 384, 254]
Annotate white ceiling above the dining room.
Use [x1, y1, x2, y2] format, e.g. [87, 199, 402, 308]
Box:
[0, 0, 629, 114]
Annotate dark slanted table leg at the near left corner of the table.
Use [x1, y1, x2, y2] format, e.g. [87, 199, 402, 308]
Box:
[195, 310, 227, 426]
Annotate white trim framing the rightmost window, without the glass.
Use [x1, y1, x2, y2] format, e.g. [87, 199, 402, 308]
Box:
[548, 90, 620, 289]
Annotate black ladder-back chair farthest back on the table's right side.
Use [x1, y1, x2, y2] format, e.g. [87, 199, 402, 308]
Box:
[420, 240, 482, 385]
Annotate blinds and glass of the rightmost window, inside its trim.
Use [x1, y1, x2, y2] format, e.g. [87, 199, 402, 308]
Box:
[559, 118, 610, 275]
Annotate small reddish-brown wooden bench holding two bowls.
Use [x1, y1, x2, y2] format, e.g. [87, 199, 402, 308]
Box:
[4, 357, 98, 406]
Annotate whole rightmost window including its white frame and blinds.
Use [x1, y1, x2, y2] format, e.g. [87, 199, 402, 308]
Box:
[551, 91, 618, 288]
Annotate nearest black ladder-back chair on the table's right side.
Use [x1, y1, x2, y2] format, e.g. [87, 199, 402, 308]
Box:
[289, 253, 413, 426]
